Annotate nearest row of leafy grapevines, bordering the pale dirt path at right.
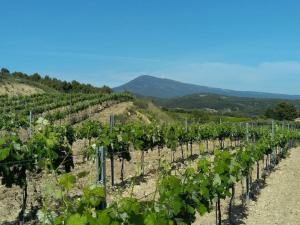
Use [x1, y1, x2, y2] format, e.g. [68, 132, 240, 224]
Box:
[40, 127, 299, 225]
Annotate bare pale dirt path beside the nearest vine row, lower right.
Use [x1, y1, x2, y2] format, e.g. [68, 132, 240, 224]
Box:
[244, 148, 300, 225]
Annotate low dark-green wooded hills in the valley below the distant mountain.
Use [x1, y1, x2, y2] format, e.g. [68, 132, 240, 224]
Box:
[154, 94, 300, 117]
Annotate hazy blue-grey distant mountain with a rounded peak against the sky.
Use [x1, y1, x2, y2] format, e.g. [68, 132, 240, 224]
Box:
[114, 75, 300, 99]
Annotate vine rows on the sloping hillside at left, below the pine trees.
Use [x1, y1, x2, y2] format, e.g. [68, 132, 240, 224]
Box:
[0, 93, 132, 130]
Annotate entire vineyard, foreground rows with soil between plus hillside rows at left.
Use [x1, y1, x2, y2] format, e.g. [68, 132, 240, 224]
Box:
[0, 93, 300, 225]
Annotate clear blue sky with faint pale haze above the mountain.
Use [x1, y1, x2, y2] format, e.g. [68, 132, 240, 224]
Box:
[0, 0, 300, 94]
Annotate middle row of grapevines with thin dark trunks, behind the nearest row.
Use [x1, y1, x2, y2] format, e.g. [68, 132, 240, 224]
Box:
[77, 121, 276, 185]
